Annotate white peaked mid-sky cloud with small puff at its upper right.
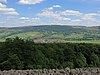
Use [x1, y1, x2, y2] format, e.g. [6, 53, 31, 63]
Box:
[37, 5, 70, 21]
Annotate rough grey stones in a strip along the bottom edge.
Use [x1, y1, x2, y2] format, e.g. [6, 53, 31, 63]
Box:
[0, 68, 100, 75]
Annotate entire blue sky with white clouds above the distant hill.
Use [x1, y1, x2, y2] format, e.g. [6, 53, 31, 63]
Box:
[0, 0, 100, 27]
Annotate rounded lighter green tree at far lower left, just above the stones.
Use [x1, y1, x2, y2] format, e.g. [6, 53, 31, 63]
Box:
[0, 54, 24, 70]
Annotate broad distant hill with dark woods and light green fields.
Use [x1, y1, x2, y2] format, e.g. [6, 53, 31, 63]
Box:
[0, 25, 100, 40]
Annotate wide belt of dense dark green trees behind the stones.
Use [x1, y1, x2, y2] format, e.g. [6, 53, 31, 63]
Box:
[0, 37, 100, 70]
